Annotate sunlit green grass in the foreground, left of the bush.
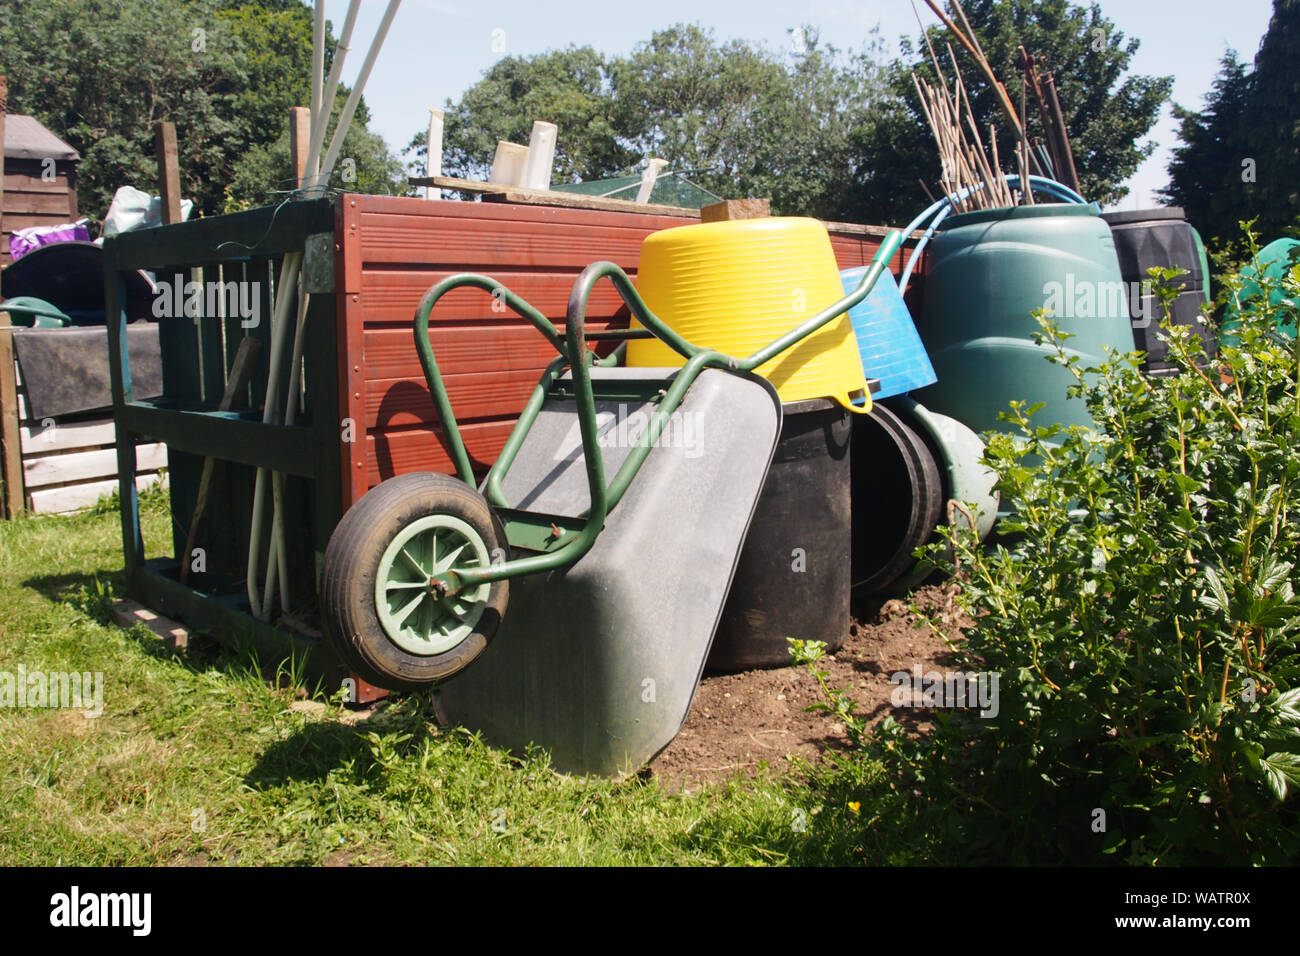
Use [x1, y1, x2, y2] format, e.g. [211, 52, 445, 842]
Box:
[0, 492, 878, 866]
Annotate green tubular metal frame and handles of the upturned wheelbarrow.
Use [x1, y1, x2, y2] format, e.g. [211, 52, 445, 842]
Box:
[415, 230, 902, 594]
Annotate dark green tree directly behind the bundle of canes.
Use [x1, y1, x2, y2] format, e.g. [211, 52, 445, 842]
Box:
[855, 0, 1173, 221]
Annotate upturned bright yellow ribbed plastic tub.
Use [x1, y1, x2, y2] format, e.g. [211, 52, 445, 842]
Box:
[627, 217, 871, 412]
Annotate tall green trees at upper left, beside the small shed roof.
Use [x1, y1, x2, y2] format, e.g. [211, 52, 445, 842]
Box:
[0, 0, 402, 216]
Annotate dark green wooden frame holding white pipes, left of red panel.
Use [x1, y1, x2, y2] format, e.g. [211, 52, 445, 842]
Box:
[104, 199, 343, 678]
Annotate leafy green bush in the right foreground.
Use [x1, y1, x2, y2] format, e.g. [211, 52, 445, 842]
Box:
[798, 226, 1300, 865]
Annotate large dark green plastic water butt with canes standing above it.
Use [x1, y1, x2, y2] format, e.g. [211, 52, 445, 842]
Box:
[913, 204, 1134, 432]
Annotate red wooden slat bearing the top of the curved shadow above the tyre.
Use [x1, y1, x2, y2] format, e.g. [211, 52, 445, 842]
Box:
[365, 369, 542, 432]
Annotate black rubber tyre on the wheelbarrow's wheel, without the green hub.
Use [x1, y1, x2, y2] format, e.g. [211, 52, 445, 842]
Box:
[321, 472, 510, 691]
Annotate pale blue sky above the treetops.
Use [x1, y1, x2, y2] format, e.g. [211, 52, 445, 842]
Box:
[325, 0, 1273, 208]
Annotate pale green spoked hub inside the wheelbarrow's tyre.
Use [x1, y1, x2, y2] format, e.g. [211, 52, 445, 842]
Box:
[374, 515, 491, 656]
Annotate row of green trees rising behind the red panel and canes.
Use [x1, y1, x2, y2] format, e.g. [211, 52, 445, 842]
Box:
[407, 0, 1171, 222]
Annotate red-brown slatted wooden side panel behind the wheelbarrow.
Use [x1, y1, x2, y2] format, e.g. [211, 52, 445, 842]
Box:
[338, 196, 925, 503]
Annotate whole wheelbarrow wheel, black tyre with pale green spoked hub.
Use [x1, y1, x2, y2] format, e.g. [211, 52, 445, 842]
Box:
[321, 472, 510, 691]
